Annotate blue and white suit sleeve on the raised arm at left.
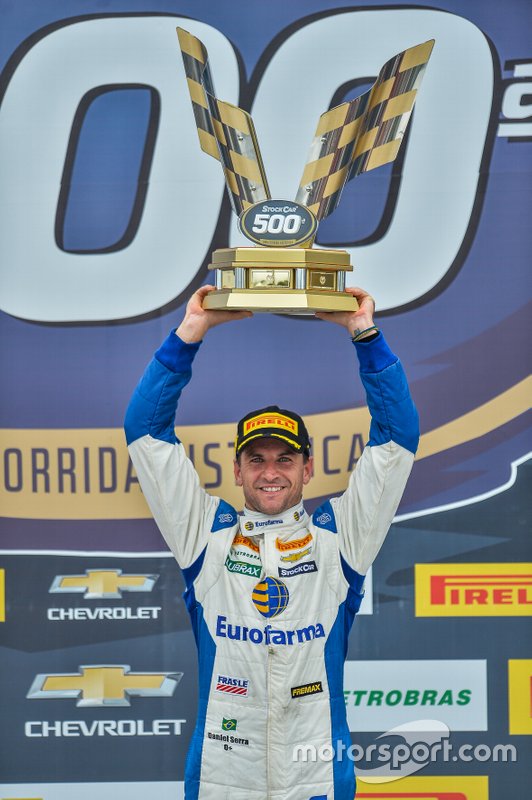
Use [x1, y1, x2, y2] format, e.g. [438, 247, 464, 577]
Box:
[125, 332, 220, 569]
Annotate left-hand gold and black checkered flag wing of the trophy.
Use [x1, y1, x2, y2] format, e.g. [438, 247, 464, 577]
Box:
[177, 28, 270, 216]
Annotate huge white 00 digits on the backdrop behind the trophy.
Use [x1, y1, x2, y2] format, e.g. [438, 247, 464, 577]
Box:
[0, 7, 493, 322]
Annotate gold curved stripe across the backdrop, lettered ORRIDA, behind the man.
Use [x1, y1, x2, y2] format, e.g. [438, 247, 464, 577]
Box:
[0, 377, 532, 520]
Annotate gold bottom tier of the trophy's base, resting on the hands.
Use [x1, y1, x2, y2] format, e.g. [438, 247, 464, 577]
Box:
[203, 289, 358, 316]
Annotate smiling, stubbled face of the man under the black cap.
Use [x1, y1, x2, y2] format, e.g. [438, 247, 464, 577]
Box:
[234, 437, 313, 516]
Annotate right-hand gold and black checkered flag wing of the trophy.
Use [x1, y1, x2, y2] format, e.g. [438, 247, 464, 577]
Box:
[296, 39, 434, 220]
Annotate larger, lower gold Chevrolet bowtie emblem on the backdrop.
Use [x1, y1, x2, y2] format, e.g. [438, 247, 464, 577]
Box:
[26, 664, 183, 706]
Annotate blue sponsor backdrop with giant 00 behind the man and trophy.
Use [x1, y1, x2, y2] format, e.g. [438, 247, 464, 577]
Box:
[0, 0, 532, 800]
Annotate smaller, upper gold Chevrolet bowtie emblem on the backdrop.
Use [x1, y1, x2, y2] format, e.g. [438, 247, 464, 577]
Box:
[50, 569, 159, 600]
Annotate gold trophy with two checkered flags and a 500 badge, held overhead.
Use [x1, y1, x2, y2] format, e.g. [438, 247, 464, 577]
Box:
[177, 28, 434, 314]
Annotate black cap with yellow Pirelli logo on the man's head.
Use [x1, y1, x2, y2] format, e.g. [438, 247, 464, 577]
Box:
[235, 406, 310, 456]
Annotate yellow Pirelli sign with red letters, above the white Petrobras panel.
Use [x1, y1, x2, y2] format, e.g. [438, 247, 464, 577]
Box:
[416, 563, 532, 617]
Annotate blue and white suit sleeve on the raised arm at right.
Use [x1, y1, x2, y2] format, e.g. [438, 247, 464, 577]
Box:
[332, 333, 419, 575]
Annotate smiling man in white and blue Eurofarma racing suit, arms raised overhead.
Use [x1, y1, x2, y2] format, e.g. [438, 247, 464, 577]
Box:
[126, 286, 418, 800]
